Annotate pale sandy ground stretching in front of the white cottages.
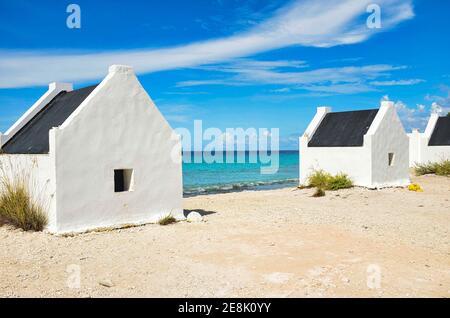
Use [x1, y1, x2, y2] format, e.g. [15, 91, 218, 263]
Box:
[0, 176, 450, 297]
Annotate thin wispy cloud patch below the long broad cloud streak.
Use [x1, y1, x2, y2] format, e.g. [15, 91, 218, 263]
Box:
[177, 60, 412, 94]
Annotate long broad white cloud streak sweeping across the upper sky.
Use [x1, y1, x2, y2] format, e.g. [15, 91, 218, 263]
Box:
[0, 0, 414, 88]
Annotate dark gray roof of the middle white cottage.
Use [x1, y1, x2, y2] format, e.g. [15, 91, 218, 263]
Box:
[308, 109, 378, 147]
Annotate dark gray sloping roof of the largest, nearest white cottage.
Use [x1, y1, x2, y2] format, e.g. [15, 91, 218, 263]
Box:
[2, 85, 97, 154]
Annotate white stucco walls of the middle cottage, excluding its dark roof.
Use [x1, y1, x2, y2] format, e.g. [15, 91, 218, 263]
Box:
[300, 103, 409, 188]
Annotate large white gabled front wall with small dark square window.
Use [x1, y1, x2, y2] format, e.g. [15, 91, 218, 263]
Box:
[50, 66, 183, 233]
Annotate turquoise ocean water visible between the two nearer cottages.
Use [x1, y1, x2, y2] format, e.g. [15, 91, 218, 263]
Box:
[183, 151, 299, 196]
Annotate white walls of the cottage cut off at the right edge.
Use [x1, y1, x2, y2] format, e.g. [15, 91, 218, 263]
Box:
[408, 114, 450, 167]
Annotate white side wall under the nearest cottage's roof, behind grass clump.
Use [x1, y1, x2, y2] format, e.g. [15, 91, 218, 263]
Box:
[0, 154, 55, 228]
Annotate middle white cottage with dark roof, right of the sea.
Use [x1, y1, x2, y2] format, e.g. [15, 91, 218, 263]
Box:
[300, 101, 409, 188]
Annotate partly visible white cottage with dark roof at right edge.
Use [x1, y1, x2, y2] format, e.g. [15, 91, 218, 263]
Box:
[408, 114, 450, 167]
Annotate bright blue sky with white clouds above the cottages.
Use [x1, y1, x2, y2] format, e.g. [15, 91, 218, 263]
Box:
[0, 0, 450, 149]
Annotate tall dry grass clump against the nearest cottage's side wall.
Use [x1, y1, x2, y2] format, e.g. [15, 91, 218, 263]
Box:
[0, 174, 48, 231]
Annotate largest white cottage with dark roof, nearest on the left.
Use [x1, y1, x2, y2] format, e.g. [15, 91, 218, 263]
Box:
[0, 65, 183, 233]
